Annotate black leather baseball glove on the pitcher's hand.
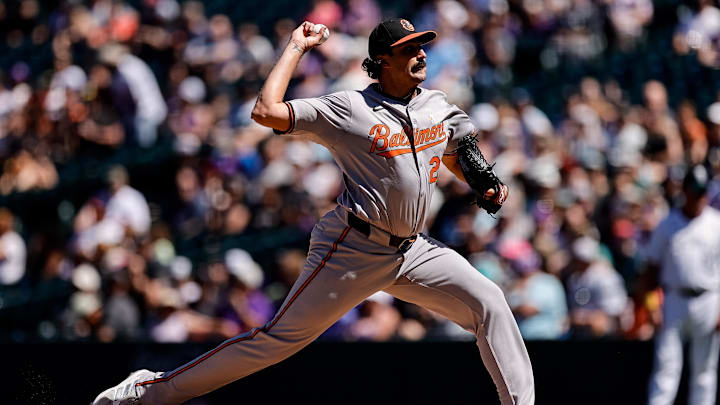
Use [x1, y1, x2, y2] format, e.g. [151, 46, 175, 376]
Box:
[457, 136, 508, 214]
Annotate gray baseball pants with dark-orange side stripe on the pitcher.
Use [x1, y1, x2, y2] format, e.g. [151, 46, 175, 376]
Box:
[139, 207, 535, 405]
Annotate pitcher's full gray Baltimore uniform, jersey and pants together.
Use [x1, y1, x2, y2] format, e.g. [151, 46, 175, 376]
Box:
[111, 86, 535, 405]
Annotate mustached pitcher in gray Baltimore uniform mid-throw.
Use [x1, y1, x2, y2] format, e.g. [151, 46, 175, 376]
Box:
[93, 19, 535, 405]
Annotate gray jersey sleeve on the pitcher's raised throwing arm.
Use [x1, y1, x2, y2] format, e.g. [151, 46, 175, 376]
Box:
[275, 92, 352, 145]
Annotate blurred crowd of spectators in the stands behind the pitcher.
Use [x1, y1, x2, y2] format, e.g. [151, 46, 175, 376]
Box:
[0, 0, 720, 342]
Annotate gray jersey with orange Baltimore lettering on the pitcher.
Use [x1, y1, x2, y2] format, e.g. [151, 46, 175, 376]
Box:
[278, 85, 475, 237]
